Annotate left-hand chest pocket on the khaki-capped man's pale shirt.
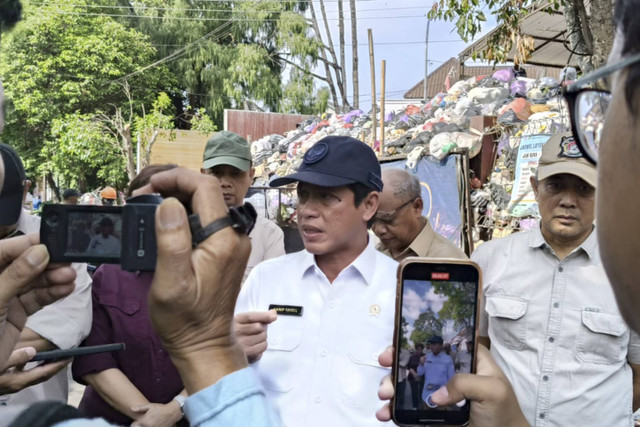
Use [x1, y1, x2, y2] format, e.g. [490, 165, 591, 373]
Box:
[485, 295, 529, 350]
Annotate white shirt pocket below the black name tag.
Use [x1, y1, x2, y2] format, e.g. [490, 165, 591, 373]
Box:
[256, 322, 302, 393]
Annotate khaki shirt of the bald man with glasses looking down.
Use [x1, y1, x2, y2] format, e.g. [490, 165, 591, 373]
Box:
[376, 218, 469, 262]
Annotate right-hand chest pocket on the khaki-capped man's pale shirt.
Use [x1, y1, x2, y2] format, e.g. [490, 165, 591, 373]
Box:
[576, 309, 629, 364]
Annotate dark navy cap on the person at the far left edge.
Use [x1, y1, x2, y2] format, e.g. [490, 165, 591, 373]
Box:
[0, 144, 26, 225]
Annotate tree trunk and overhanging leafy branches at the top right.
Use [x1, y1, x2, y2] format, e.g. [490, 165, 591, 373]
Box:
[428, 0, 613, 72]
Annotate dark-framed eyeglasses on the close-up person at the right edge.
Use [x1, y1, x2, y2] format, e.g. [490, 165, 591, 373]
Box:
[563, 50, 640, 165]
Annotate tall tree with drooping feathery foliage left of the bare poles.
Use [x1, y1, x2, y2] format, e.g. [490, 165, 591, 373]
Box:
[102, 0, 328, 123]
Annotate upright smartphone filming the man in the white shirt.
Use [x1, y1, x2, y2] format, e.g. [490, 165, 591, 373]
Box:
[392, 258, 482, 426]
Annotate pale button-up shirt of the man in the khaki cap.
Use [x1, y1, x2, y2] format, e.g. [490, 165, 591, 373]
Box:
[471, 227, 640, 427]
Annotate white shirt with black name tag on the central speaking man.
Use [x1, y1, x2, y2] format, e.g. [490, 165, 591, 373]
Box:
[236, 242, 398, 427]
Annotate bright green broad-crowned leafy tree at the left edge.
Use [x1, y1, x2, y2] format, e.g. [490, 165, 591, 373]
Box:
[0, 0, 173, 189]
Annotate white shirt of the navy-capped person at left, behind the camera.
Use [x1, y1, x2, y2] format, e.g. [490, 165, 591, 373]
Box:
[0, 211, 92, 405]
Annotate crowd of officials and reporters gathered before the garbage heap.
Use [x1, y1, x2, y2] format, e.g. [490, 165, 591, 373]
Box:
[0, 0, 640, 427]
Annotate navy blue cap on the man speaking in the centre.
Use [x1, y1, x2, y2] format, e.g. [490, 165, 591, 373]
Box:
[269, 136, 382, 191]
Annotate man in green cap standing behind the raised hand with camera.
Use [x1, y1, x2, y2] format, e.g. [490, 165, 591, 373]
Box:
[200, 131, 285, 282]
